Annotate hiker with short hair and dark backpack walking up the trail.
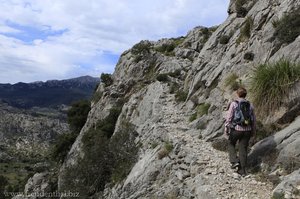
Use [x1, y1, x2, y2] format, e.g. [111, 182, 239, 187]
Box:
[225, 87, 256, 176]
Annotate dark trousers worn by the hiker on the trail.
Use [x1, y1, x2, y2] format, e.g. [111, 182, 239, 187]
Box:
[228, 130, 251, 169]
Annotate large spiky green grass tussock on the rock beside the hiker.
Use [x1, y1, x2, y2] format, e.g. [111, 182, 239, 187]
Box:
[250, 59, 300, 115]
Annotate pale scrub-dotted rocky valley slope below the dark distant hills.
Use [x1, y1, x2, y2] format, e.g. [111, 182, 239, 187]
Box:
[0, 103, 69, 162]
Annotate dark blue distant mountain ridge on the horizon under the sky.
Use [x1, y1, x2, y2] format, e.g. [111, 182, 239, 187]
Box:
[0, 76, 100, 109]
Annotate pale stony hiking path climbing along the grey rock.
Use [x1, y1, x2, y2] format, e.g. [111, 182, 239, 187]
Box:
[148, 91, 272, 199]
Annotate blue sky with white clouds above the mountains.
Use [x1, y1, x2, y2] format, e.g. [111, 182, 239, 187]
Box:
[0, 0, 229, 84]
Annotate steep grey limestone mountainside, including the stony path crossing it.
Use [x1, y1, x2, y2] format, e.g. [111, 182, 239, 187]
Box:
[53, 0, 300, 198]
